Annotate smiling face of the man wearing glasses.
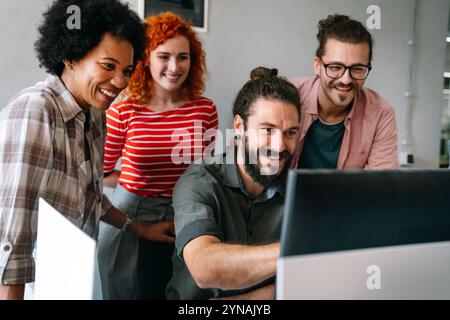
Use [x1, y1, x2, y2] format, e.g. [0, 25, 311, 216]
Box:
[314, 39, 370, 109]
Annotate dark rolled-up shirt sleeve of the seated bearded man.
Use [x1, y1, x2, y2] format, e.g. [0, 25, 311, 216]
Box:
[172, 164, 223, 257]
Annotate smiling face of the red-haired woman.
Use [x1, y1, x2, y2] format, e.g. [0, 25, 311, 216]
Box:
[150, 35, 191, 93]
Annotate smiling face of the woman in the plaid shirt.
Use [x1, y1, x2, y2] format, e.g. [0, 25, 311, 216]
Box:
[61, 33, 134, 110]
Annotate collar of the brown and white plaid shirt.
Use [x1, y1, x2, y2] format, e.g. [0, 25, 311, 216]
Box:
[45, 75, 84, 123]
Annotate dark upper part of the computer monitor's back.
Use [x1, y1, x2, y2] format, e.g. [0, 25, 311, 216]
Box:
[281, 170, 450, 256]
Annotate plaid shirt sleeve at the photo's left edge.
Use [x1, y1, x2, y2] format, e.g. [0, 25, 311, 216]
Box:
[0, 94, 52, 284]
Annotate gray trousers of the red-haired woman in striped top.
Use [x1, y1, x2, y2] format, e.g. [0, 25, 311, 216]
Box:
[97, 185, 174, 300]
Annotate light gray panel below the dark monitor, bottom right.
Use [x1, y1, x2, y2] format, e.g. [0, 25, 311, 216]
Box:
[277, 242, 450, 300]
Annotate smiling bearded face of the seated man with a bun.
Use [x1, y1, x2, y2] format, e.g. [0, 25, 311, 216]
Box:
[234, 98, 299, 187]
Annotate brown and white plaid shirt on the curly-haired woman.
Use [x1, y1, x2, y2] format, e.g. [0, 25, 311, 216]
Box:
[0, 76, 111, 284]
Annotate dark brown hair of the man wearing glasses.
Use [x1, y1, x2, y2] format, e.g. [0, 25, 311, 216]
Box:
[316, 14, 374, 62]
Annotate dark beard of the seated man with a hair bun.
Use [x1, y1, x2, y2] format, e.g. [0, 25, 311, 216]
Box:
[244, 144, 292, 189]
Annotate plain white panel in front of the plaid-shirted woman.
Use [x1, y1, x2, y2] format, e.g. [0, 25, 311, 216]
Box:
[30, 198, 96, 300]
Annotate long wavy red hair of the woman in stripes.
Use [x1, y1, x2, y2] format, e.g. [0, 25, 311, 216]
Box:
[125, 12, 206, 100]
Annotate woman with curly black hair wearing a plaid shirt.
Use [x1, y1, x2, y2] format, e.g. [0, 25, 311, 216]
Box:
[0, 0, 167, 299]
